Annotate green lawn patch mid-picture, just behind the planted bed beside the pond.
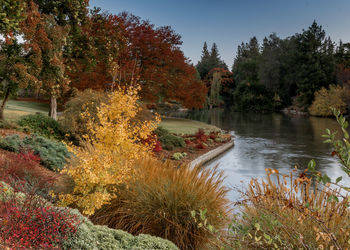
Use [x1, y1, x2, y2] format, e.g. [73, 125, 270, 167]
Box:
[160, 118, 221, 134]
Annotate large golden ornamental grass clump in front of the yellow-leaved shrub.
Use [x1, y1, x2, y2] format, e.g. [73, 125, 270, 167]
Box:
[91, 159, 229, 249]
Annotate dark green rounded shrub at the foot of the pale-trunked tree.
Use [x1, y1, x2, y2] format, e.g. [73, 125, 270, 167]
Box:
[17, 113, 65, 140]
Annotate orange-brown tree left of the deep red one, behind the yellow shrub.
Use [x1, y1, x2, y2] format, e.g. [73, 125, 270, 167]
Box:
[67, 9, 126, 90]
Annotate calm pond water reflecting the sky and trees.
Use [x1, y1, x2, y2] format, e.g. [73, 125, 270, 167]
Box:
[180, 110, 349, 200]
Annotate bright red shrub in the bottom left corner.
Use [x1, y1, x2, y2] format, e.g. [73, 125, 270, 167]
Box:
[0, 183, 80, 249]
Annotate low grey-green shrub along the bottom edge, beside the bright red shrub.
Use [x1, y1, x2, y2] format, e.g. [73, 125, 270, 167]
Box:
[0, 182, 178, 250]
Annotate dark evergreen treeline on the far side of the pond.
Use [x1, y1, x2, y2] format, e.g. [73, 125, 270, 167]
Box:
[197, 21, 350, 111]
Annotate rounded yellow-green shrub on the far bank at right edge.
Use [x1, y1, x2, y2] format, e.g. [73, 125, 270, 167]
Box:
[309, 85, 346, 116]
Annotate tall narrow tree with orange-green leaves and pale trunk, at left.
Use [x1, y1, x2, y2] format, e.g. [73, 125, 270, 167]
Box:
[21, 1, 70, 119]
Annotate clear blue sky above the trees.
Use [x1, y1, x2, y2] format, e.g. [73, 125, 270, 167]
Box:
[90, 0, 350, 68]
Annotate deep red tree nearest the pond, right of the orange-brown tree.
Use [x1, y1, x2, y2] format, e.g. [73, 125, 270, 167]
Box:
[119, 13, 206, 108]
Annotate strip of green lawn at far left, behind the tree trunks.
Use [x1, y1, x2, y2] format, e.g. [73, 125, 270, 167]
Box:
[4, 100, 49, 121]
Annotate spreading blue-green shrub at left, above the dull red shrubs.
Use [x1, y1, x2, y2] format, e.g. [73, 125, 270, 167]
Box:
[0, 135, 70, 171]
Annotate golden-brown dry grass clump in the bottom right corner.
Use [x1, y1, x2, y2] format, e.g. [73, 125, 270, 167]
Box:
[237, 169, 350, 249]
